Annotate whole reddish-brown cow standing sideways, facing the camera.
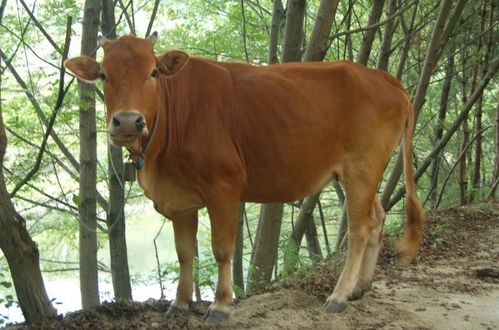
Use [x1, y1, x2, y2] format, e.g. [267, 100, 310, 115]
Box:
[65, 35, 424, 323]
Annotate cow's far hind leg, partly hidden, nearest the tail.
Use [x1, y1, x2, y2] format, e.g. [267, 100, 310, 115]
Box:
[350, 196, 385, 300]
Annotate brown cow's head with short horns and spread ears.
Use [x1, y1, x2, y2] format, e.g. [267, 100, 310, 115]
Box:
[64, 33, 188, 147]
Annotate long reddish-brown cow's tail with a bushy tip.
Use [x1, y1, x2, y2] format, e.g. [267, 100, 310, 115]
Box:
[397, 103, 425, 263]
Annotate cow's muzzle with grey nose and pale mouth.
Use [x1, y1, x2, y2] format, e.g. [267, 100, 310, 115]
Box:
[107, 111, 149, 147]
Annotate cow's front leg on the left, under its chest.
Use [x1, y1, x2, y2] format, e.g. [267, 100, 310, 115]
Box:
[166, 211, 198, 316]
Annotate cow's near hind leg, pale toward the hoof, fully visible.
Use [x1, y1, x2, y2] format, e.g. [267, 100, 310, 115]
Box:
[323, 171, 377, 313]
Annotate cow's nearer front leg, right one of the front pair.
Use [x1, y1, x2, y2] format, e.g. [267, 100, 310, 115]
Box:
[205, 199, 238, 324]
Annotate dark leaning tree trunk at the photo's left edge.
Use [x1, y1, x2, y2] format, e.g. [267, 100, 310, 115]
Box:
[0, 0, 56, 324]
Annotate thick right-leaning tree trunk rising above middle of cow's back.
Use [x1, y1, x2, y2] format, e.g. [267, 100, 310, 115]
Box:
[304, 0, 340, 62]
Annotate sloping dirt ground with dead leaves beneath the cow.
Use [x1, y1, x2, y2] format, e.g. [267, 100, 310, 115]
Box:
[4, 202, 499, 329]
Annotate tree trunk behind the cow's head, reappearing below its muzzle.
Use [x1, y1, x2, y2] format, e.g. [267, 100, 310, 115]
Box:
[102, 0, 132, 300]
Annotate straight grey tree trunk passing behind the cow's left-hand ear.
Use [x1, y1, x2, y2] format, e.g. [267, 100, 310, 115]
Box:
[78, 0, 101, 309]
